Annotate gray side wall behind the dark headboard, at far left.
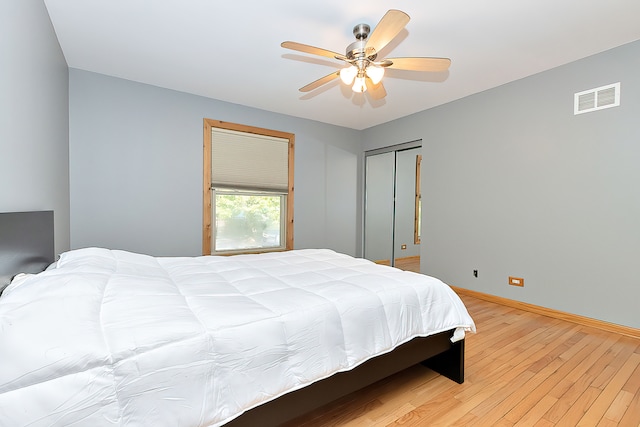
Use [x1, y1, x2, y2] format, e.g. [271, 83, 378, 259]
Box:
[0, 0, 69, 253]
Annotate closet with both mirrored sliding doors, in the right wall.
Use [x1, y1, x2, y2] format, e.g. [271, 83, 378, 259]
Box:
[364, 141, 422, 272]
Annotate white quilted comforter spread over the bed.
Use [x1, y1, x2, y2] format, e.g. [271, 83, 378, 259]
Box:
[0, 248, 475, 426]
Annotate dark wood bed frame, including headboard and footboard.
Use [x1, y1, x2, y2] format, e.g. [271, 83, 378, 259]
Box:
[0, 211, 464, 427]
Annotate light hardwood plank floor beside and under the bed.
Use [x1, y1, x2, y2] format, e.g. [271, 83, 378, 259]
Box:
[292, 295, 640, 427]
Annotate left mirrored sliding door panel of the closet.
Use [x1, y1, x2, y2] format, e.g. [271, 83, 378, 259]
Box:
[364, 152, 395, 265]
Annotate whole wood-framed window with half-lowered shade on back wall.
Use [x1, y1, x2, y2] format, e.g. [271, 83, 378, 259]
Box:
[202, 119, 294, 255]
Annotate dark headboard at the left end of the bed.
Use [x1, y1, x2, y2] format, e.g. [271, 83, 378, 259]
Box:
[0, 211, 55, 293]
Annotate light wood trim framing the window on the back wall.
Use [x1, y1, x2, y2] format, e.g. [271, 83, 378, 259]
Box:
[202, 119, 295, 255]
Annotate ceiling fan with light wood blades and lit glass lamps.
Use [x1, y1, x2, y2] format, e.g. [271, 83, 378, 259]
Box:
[281, 9, 451, 99]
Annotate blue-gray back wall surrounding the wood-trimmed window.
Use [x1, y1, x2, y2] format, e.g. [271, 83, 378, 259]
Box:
[69, 69, 362, 255]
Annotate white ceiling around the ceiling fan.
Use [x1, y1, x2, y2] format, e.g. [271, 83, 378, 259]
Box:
[44, 0, 640, 129]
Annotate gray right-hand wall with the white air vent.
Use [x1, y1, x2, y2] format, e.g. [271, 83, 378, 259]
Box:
[363, 42, 640, 327]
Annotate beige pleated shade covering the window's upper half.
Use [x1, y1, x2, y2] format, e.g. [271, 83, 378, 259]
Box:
[211, 128, 289, 193]
